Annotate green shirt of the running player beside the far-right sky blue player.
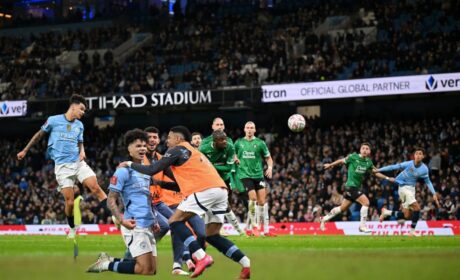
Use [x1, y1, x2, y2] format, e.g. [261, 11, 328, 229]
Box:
[345, 153, 374, 188]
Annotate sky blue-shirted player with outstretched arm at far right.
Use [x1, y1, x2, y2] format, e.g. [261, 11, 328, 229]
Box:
[378, 148, 439, 236]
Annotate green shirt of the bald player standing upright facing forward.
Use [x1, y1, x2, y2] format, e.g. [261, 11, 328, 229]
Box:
[235, 137, 270, 179]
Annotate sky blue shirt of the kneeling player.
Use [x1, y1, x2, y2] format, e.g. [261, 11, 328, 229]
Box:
[109, 168, 156, 228]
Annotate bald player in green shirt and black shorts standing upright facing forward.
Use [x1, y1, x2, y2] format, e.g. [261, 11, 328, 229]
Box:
[235, 122, 273, 236]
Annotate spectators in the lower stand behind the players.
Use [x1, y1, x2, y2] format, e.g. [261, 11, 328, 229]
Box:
[0, 118, 460, 224]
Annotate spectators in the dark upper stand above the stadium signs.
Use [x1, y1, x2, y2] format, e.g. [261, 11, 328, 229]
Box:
[0, 0, 460, 99]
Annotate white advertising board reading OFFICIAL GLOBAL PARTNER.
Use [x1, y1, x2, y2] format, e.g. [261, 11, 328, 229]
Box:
[262, 73, 460, 102]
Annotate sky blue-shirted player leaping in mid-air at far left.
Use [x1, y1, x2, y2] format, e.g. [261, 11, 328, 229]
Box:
[17, 94, 108, 238]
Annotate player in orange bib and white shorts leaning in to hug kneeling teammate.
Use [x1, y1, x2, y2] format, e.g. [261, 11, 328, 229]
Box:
[120, 126, 250, 279]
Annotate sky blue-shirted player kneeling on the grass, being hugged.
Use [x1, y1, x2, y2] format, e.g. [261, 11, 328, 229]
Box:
[87, 129, 160, 275]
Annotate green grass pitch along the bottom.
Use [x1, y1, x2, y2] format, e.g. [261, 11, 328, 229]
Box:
[0, 236, 460, 280]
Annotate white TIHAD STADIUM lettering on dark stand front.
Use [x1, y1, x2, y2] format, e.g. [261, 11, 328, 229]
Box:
[86, 90, 212, 110]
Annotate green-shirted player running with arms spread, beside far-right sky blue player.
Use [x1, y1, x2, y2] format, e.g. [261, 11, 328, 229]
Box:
[320, 143, 394, 232]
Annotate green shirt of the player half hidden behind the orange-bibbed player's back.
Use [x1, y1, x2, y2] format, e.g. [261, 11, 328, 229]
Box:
[200, 141, 235, 181]
